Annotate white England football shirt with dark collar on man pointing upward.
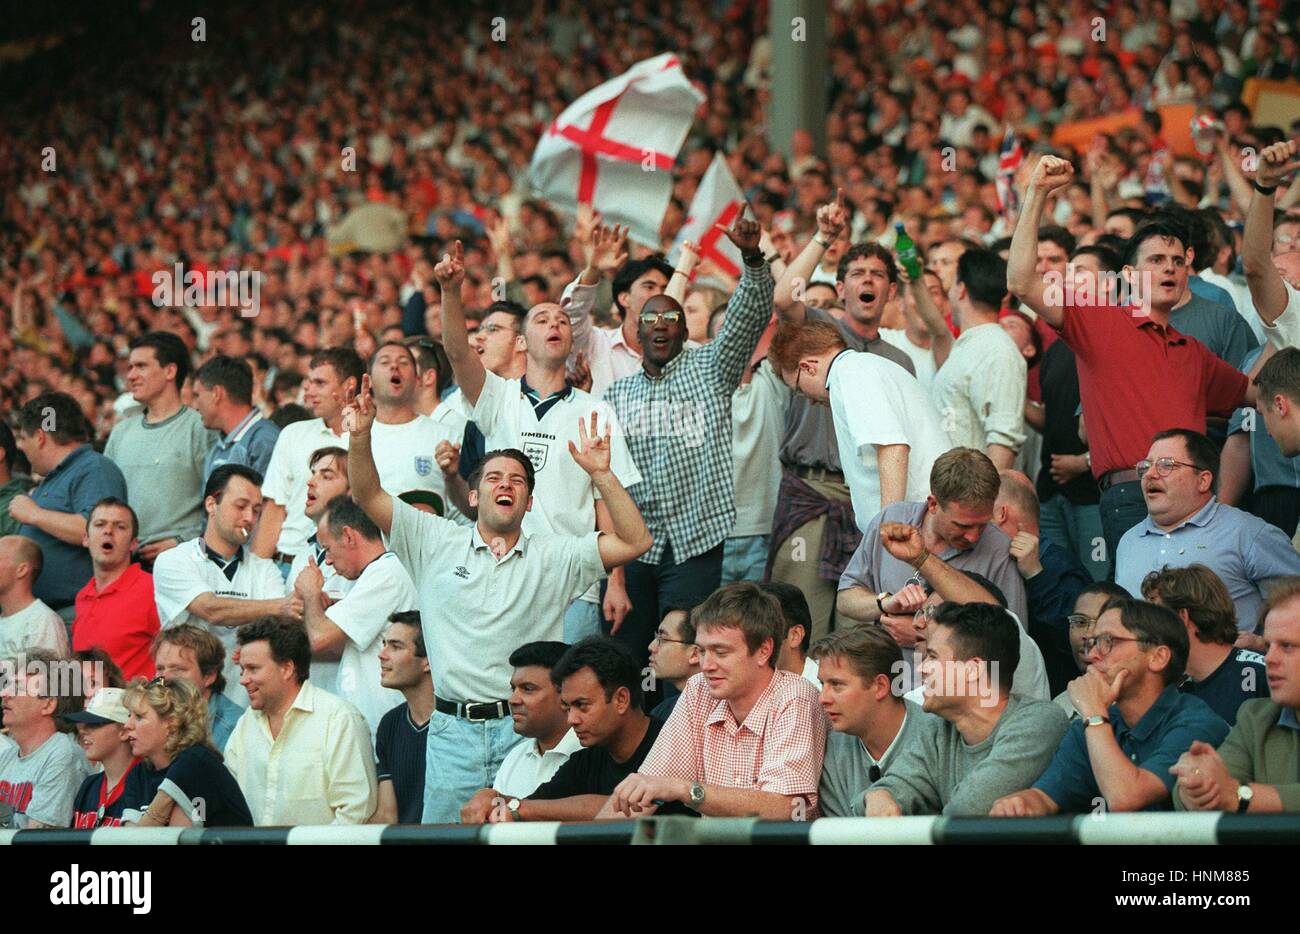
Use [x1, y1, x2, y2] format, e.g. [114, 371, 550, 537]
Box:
[471, 372, 641, 602]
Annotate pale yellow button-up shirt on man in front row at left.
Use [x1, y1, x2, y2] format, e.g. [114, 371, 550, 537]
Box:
[225, 680, 378, 826]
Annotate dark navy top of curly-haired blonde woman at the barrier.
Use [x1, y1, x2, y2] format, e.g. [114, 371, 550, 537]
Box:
[122, 745, 252, 827]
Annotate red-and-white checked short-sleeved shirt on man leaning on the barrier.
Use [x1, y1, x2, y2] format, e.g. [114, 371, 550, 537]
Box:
[640, 671, 827, 817]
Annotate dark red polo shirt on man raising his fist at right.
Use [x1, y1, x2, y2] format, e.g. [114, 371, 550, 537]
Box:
[1061, 306, 1249, 479]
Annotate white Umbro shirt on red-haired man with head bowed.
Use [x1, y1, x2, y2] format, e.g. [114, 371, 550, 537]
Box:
[827, 350, 952, 532]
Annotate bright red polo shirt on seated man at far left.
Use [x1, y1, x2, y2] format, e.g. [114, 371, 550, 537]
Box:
[73, 565, 159, 680]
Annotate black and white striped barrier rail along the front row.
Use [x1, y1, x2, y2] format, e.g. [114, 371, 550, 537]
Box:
[0, 813, 1300, 846]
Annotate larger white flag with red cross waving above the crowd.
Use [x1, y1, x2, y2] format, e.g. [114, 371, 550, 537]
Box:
[529, 52, 705, 248]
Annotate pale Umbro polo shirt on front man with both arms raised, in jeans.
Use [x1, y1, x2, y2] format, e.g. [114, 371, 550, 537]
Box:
[389, 500, 606, 704]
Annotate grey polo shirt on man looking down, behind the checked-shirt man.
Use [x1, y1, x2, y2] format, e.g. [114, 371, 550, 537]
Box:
[840, 502, 1030, 629]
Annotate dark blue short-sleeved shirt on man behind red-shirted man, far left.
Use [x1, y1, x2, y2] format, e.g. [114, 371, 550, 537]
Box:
[18, 445, 126, 610]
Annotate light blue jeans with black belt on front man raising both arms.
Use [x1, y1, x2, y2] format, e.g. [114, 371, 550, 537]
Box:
[420, 710, 521, 823]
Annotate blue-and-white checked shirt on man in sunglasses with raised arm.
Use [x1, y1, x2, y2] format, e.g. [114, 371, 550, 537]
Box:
[605, 263, 776, 565]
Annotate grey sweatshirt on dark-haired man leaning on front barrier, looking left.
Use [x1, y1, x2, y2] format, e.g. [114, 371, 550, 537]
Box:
[871, 695, 1069, 817]
